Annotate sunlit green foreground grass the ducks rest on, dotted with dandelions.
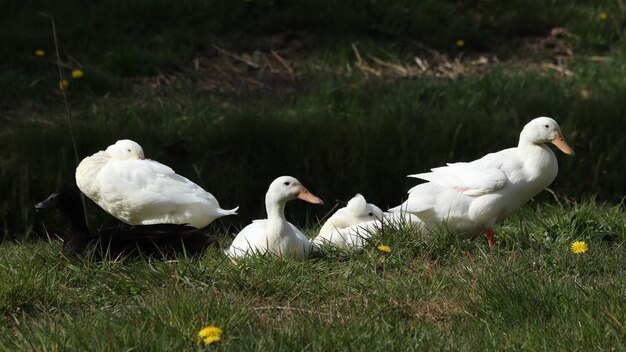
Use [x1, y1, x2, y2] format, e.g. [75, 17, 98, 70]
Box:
[0, 201, 626, 351]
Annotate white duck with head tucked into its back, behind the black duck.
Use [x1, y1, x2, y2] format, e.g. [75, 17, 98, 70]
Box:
[76, 139, 237, 228]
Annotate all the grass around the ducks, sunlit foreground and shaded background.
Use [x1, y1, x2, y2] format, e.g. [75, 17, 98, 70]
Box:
[0, 0, 626, 351]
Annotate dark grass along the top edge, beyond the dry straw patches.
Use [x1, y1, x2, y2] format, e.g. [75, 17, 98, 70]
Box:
[0, 0, 626, 103]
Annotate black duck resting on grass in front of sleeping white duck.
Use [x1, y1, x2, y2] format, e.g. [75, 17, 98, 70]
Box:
[35, 188, 218, 259]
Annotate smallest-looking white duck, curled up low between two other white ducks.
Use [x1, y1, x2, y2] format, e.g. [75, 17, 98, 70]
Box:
[313, 194, 383, 249]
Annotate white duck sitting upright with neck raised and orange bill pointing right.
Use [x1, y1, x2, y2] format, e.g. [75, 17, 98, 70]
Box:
[225, 176, 324, 259]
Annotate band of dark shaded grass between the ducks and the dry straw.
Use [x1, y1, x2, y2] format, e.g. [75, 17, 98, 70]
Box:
[0, 61, 626, 238]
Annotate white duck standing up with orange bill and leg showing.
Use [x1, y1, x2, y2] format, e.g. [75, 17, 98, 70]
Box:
[390, 117, 574, 248]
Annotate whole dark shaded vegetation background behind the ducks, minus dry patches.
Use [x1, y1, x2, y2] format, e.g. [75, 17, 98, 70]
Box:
[0, 0, 626, 238]
